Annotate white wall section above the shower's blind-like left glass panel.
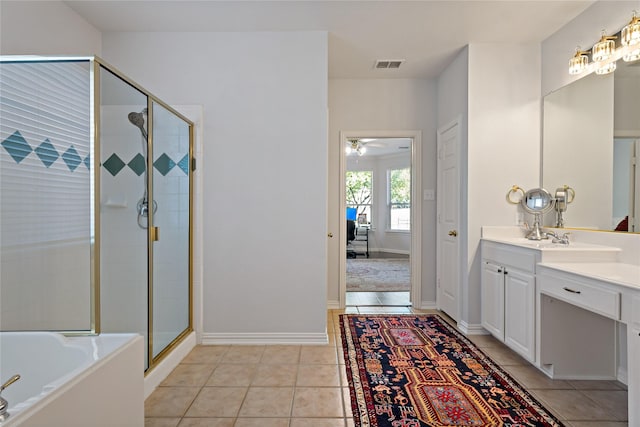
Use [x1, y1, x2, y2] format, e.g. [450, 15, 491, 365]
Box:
[0, 0, 102, 56]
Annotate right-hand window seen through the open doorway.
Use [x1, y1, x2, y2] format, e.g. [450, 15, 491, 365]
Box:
[387, 168, 411, 231]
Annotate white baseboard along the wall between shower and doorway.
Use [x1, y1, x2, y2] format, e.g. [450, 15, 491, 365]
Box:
[202, 332, 329, 345]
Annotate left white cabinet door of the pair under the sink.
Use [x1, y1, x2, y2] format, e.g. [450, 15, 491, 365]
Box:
[481, 262, 504, 341]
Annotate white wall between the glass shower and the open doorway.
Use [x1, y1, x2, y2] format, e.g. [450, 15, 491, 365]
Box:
[103, 32, 327, 342]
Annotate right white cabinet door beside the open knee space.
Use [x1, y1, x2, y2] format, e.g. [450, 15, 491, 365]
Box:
[504, 270, 535, 362]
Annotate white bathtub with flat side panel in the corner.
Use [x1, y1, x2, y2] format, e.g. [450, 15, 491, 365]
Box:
[0, 332, 144, 427]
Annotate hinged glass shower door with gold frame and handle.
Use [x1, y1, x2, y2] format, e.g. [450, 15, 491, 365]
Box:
[149, 101, 191, 359]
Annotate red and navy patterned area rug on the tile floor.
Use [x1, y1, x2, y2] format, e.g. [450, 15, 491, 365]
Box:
[340, 314, 562, 427]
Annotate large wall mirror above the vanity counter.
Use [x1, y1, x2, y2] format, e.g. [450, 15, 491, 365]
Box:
[542, 61, 640, 232]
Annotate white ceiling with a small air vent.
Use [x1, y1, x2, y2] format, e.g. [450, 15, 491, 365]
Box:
[65, 0, 593, 78]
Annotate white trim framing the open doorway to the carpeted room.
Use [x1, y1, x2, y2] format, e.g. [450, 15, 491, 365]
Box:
[338, 130, 422, 308]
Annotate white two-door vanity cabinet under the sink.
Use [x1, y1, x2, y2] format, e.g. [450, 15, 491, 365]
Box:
[481, 241, 539, 362]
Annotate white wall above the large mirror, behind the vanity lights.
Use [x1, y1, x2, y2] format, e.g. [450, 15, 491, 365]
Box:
[541, 0, 640, 95]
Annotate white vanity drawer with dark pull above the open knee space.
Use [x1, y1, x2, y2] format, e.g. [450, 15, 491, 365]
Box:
[538, 274, 620, 320]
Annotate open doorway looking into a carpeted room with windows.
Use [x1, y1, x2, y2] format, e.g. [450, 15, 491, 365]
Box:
[340, 132, 421, 307]
